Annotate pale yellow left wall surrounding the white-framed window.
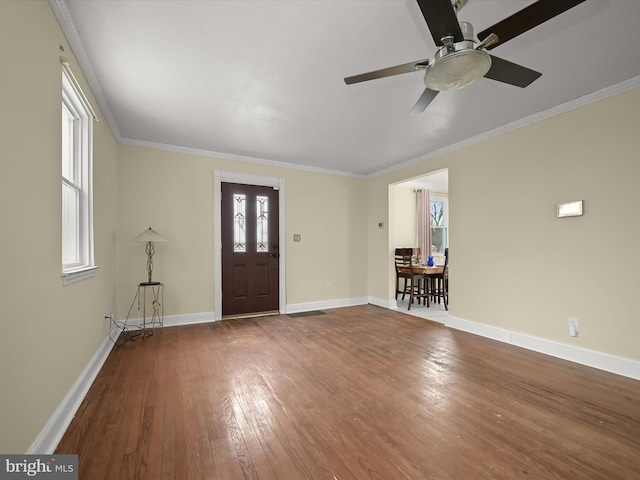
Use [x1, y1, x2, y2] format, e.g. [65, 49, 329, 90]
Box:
[0, 1, 118, 453]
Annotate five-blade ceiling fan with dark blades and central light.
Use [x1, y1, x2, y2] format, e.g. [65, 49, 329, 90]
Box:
[344, 0, 585, 115]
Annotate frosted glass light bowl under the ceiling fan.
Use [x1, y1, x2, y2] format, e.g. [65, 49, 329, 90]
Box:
[424, 49, 491, 92]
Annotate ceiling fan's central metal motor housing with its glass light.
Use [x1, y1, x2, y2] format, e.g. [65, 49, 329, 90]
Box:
[424, 22, 491, 91]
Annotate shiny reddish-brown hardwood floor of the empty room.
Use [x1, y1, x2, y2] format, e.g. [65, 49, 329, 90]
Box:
[56, 306, 640, 480]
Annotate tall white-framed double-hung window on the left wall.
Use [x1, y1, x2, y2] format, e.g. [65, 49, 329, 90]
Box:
[62, 70, 97, 285]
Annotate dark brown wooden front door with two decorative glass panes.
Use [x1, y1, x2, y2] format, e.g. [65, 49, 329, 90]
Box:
[221, 183, 280, 316]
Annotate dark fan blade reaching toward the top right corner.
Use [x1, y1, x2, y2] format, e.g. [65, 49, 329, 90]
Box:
[478, 0, 585, 50]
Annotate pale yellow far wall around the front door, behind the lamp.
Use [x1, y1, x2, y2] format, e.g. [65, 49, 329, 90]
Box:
[117, 145, 367, 318]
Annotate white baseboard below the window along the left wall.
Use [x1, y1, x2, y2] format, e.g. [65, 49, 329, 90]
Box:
[27, 337, 113, 455]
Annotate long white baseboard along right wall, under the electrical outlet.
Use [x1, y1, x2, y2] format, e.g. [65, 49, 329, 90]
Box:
[445, 315, 640, 380]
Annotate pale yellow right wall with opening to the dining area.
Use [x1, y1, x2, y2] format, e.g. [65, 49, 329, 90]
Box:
[368, 88, 640, 360]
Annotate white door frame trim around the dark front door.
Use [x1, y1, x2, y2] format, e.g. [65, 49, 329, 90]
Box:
[213, 170, 287, 320]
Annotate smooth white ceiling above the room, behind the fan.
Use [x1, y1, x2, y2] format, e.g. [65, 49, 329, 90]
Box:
[50, 0, 640, 176]
